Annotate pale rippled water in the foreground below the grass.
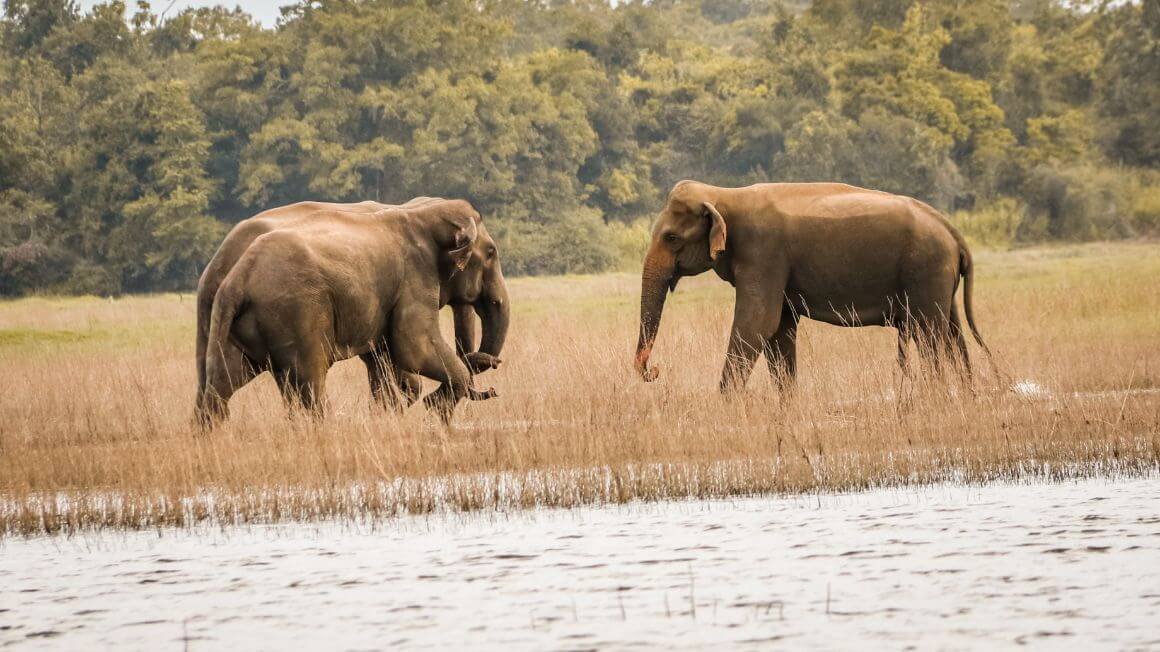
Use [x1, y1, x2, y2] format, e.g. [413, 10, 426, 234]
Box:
[0, 477, 1160, 650]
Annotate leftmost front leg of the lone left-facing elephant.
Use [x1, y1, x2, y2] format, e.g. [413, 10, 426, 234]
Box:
[720, 282, 784, 393]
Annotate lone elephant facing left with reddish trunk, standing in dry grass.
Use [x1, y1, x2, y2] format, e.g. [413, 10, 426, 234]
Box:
[635, 180, 994, 393]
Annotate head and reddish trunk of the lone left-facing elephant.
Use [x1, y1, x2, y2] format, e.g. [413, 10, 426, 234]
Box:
[636, 181, 727, 382]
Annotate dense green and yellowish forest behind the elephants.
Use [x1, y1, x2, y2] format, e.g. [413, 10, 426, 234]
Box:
[0, 0, 1160, 295]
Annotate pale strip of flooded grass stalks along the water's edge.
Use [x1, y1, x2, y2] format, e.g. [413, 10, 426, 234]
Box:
[0, 452, 1160, 538]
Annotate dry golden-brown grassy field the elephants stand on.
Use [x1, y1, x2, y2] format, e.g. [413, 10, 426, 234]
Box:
[0, 244, 1160, 536]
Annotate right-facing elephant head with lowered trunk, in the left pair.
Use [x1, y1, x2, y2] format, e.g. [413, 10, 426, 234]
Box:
[419, 201, 512, 372]
